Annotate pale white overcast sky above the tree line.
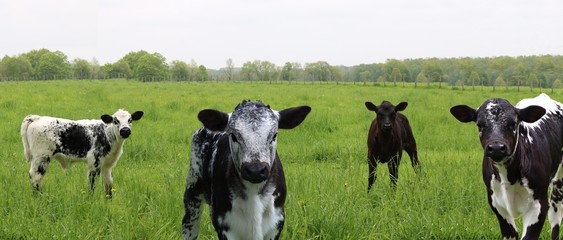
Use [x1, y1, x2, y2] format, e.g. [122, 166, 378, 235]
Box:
[0, 0, 563, 69]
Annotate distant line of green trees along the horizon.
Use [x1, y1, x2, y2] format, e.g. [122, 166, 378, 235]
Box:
[0, 49, 563, 88]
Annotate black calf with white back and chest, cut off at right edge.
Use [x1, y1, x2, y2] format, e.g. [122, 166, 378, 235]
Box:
[450, 94, 563, 239]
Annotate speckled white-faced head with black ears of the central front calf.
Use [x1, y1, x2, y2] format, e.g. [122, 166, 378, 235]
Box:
[198, 101, 311, 183]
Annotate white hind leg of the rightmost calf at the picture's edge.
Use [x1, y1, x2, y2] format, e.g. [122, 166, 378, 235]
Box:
[547, 165, 563, 239]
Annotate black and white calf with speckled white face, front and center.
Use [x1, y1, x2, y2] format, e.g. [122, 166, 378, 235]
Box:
[182, 101, 311, 240]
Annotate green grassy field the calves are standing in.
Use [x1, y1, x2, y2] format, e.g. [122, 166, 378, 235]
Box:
[0, 80, 563, 239]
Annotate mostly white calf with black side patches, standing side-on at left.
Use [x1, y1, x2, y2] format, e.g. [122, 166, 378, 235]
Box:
[21, 109, 143, 197]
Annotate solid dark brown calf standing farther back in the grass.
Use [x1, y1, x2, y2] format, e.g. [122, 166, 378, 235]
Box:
[366, 101, 420, 192]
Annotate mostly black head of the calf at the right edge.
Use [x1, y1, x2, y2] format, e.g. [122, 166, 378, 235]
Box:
[450, 98, 545, 163]
